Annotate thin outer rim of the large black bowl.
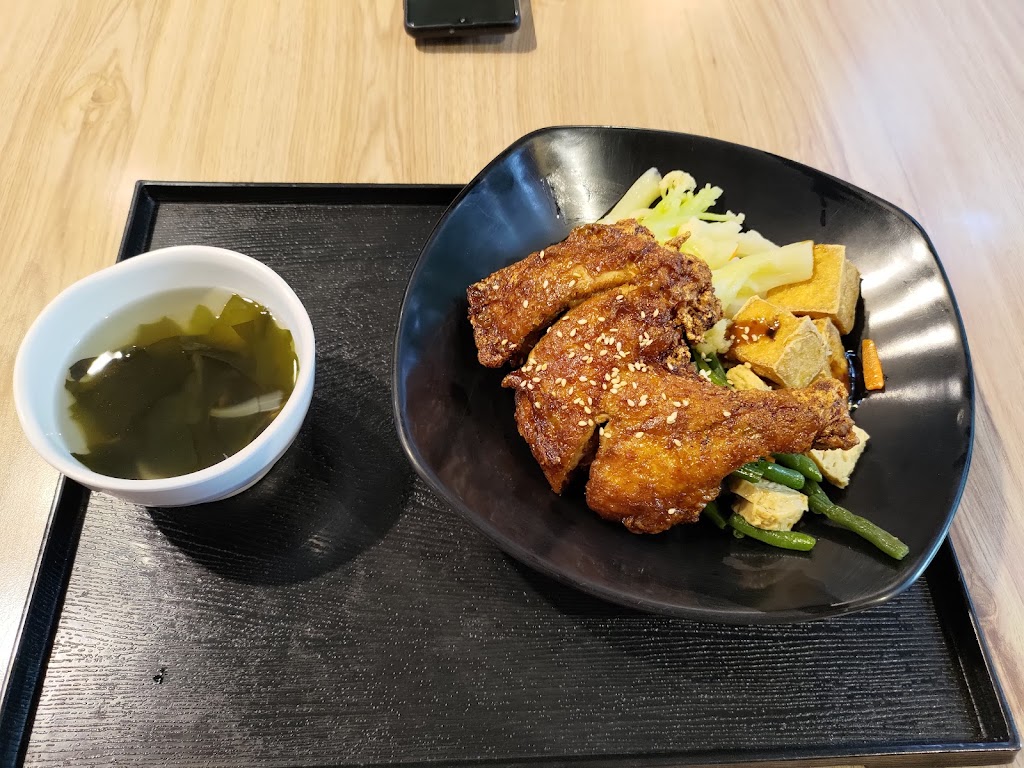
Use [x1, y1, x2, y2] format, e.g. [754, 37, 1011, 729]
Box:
[391, 125, 976, 625]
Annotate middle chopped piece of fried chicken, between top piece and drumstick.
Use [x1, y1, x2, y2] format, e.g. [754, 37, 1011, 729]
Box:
[503, 247, 721, 493]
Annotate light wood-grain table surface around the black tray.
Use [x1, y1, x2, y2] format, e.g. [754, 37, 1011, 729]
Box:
[0, 0, 1024, 765]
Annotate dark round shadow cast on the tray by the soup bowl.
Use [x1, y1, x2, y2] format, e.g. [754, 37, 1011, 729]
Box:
[148, 361, 412, 584]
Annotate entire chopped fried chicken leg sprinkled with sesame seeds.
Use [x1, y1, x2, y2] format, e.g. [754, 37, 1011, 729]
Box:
[467, 221, 857, 534]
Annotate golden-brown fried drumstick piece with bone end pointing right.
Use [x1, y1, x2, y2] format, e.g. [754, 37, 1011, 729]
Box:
[587, 369, 857, 534]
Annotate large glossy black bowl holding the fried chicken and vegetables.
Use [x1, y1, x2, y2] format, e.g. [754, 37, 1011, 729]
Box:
[393, 127, 974, 623]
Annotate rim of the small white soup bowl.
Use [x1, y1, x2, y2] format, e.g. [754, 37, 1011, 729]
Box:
[13, 245, 315, 495]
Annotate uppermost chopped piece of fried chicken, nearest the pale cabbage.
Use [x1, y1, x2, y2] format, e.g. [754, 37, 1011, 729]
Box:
[466, 220, 721, 368]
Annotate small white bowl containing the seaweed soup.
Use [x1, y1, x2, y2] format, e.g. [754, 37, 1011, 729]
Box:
[14, 246, 315, 507]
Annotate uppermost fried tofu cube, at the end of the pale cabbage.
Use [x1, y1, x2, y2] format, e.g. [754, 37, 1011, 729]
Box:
[765, 245, 860, 334]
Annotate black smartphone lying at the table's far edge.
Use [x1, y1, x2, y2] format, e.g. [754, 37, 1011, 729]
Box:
[404, 0, 519, 38]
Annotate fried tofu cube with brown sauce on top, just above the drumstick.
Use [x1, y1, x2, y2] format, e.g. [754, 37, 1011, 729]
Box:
[729, 296, 828, 387]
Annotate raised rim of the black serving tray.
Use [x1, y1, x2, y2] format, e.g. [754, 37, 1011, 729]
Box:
[0, 180, 1021, 767]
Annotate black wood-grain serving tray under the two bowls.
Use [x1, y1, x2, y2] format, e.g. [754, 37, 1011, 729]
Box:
[0, 182, 1019, 767]
